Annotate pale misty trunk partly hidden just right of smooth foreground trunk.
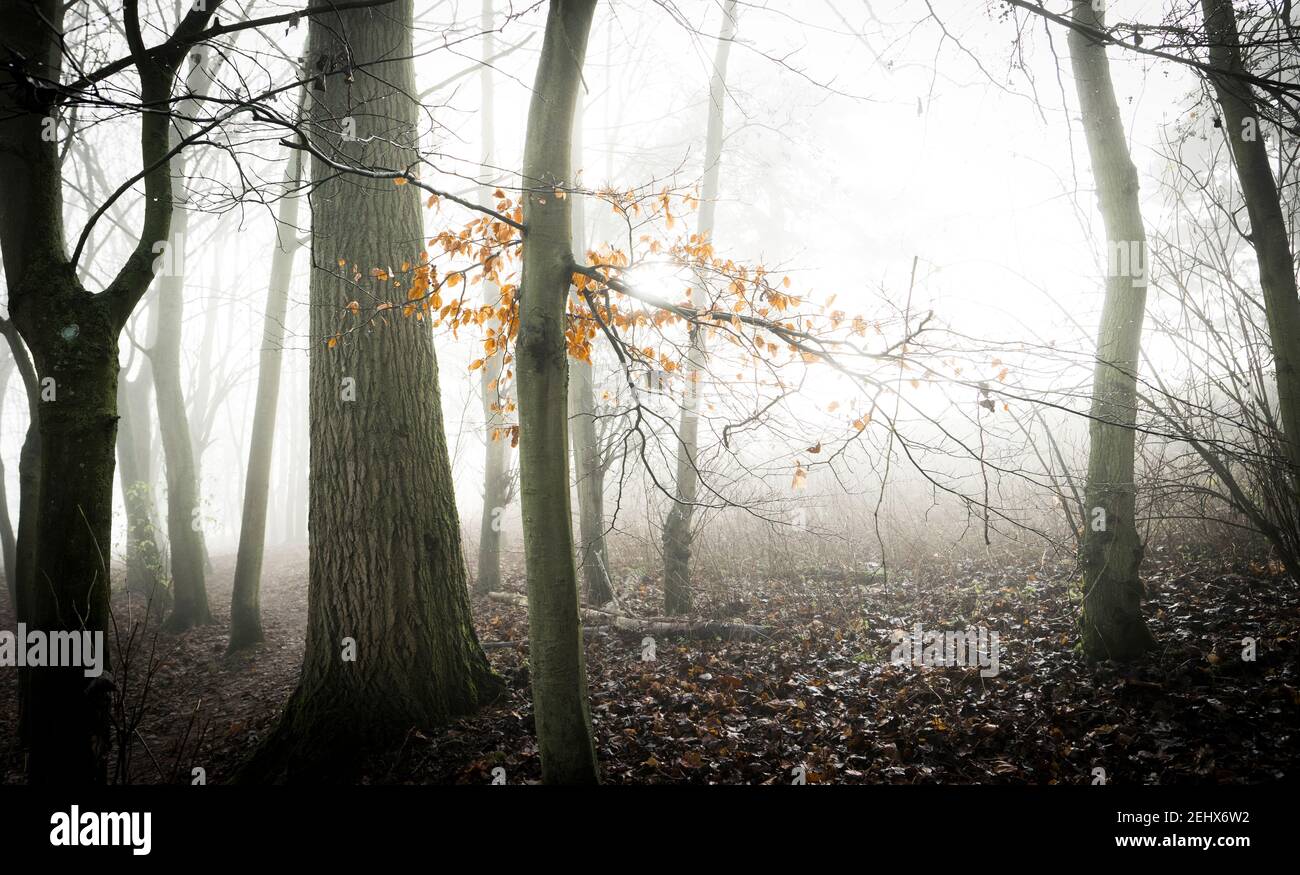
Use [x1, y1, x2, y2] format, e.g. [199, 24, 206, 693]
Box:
[568, 92, 614, 606]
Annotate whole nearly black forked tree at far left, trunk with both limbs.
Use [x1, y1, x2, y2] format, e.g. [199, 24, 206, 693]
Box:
[0, 0, 215, 784]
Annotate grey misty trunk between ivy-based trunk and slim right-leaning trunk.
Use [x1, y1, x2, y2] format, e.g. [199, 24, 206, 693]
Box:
[150, 47, 212, 632]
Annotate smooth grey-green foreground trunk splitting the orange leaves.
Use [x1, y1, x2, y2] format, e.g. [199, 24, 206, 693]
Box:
[516, 0, 598, 784]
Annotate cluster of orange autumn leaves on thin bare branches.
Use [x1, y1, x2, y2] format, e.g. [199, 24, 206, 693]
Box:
[328, 177, 1006, 443]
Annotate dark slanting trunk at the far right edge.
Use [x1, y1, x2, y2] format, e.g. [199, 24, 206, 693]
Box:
[1201, 0, 1300, 493]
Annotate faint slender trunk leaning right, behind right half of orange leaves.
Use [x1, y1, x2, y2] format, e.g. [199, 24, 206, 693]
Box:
[663, 0, 736, 615]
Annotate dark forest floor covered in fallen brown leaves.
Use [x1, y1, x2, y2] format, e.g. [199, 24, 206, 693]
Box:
[0, 549, 1300, 784]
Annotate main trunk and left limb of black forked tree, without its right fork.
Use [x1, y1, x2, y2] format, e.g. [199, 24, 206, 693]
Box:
[0, 0, 111, 784]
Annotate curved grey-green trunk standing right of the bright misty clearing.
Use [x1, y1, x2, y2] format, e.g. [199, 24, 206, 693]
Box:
[1069, 0, 1154, 660]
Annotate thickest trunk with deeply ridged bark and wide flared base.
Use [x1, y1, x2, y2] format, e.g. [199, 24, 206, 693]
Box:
[241, 0, 499, 780]
